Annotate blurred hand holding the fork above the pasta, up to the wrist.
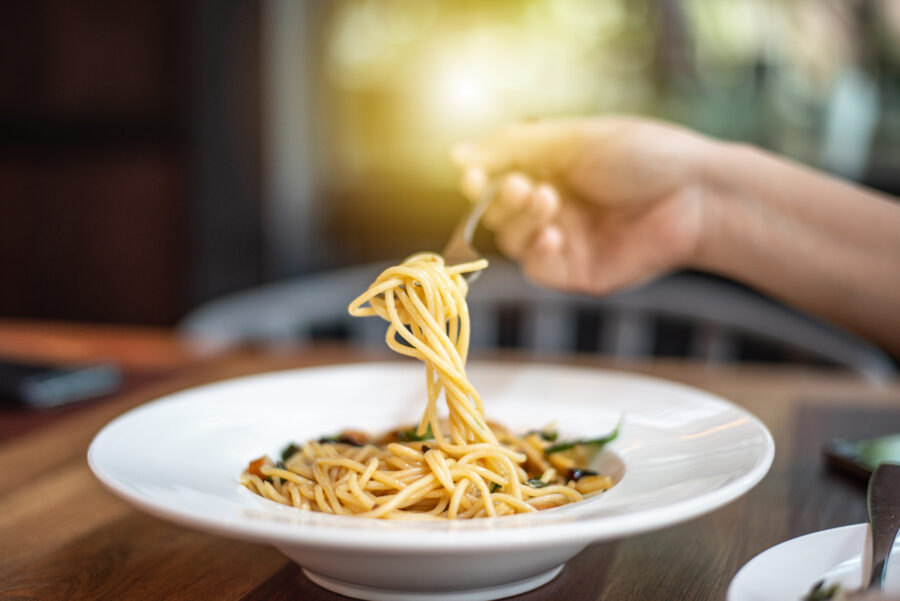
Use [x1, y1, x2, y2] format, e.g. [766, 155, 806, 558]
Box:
[453, 118, 716, 294]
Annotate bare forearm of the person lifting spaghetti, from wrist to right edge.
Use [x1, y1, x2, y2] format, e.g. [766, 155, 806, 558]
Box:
[696, 144, 900, 356]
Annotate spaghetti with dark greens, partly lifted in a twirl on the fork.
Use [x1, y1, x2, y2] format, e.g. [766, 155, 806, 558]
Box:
[241, 253, 616, 520]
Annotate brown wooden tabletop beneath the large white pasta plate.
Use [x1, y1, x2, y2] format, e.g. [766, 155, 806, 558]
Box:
[0, 321, 900, 601]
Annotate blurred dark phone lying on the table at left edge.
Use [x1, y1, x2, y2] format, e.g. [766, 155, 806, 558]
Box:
[0, 359, 122, 409]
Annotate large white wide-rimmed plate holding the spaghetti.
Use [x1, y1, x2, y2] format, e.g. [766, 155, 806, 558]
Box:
[88, 363, 774, 601]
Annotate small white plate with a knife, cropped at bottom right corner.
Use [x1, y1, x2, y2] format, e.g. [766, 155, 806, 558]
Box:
[728, 524, 900, 601]
